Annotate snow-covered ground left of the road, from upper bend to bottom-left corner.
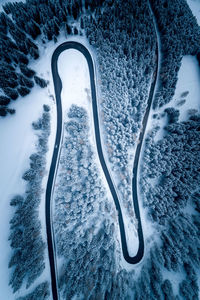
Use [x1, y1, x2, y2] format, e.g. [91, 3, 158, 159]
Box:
[0, 31, 69, 300]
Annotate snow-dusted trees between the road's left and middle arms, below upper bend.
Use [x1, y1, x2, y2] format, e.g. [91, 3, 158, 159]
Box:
[53, 105, 120, 299]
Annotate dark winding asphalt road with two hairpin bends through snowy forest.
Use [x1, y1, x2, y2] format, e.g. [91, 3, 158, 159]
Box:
[45, 4, 158, 300]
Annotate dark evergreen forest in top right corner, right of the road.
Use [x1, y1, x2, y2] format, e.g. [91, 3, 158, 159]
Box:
[150, 0, 200, 108]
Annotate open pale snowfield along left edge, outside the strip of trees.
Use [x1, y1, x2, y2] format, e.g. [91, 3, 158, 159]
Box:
[0, 87, 52, 299]
